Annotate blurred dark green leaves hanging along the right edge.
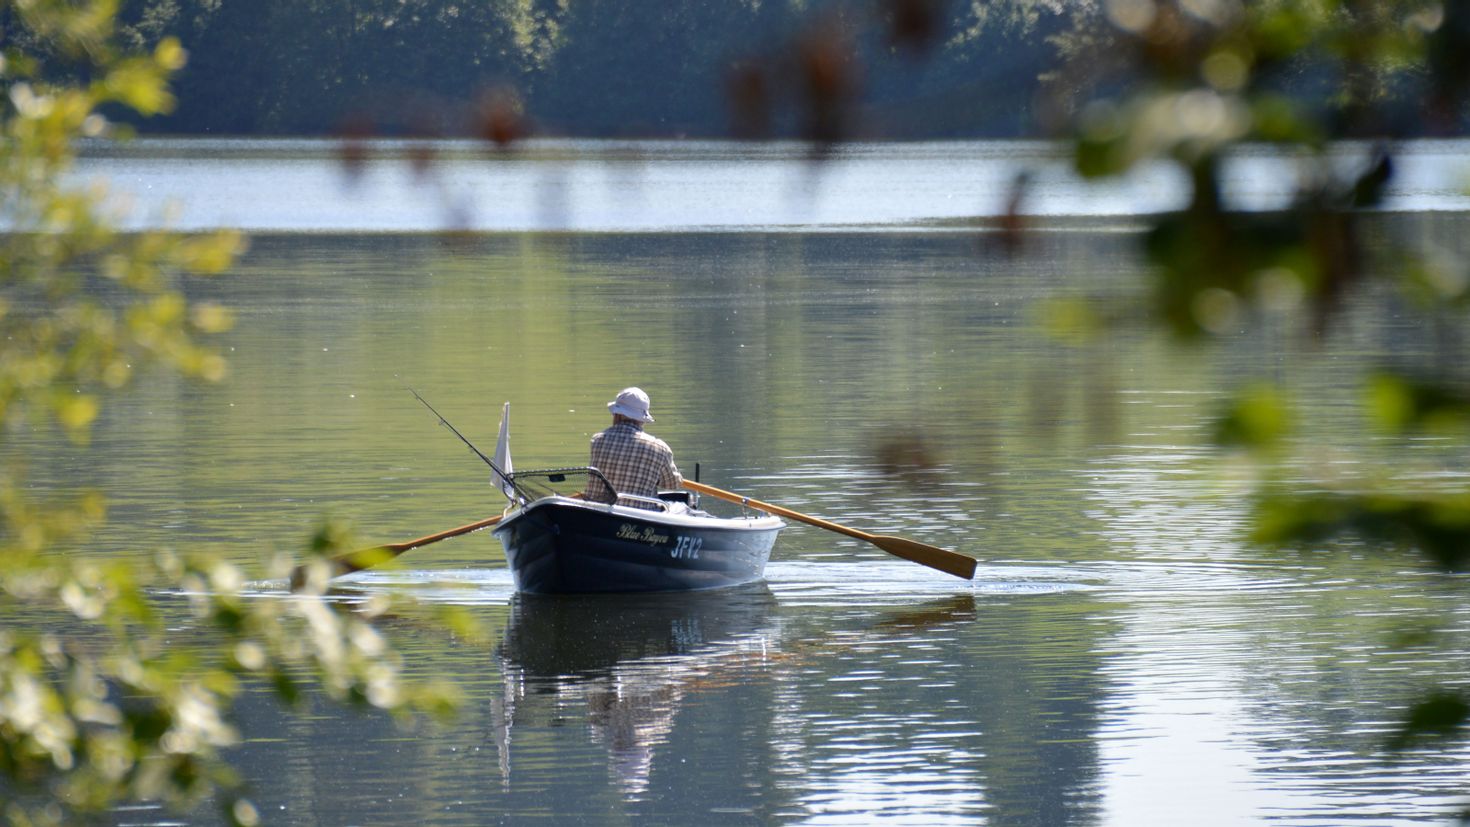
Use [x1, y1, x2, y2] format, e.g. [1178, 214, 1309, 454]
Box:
[1058, 0, 1470, 748]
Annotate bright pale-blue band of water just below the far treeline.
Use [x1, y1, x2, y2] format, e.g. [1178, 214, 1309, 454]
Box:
[79, 140, 1470, 232]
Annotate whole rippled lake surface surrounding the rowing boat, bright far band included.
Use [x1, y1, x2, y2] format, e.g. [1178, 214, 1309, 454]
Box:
[25, 141, 1470, 826]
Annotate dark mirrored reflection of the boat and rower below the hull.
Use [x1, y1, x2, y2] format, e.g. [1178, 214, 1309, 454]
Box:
[492, 582, 778, 796]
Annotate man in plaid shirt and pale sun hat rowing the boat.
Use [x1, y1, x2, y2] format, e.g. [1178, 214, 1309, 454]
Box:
[584, 388, 684, 510]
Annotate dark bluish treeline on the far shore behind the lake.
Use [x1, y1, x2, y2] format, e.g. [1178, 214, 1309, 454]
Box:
[122, 0, 1070, 138]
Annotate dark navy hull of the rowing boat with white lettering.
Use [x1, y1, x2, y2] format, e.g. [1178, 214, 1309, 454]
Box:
[494, 498, 785, 595]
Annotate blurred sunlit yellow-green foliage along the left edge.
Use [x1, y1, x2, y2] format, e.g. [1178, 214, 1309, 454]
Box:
[0, 0, 453, 824]
